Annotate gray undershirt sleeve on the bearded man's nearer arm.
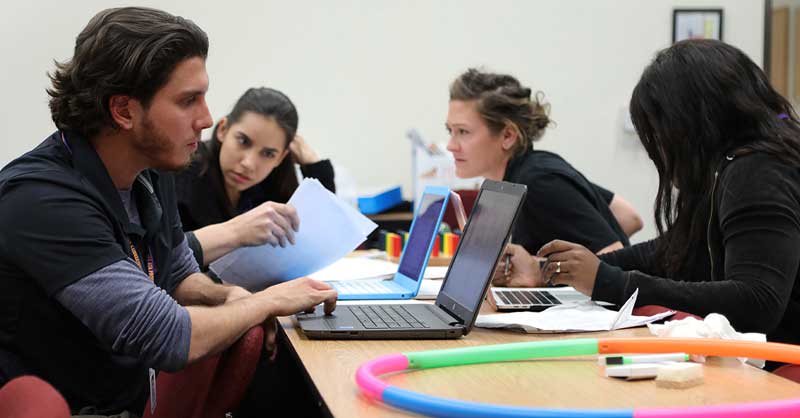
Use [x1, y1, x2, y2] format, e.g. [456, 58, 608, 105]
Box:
[55, 262, 192, 371]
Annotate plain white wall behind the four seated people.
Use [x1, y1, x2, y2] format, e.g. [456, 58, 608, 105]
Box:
[0, 0, 764, 241]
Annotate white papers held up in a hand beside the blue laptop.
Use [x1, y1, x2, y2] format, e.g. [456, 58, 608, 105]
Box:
[210, 178, 377, 291]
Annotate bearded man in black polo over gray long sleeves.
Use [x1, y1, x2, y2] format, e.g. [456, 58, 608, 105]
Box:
[0, 8, 336, 415]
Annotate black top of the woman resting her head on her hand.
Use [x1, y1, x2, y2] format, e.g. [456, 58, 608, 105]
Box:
[175, 140, 336, 267]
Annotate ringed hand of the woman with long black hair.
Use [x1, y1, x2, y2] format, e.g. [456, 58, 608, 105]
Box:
[537, 240, 600, 296]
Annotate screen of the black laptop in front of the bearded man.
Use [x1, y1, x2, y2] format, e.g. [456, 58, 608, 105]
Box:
[441, 188, 521, 309]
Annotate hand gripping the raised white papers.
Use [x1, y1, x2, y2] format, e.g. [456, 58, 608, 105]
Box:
[229, 202, 300, 247]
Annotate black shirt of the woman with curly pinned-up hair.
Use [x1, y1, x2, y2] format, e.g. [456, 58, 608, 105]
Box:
[503, 150, 630, 254]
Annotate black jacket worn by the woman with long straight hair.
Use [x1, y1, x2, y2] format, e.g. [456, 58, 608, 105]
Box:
[592, 153, 800, 344]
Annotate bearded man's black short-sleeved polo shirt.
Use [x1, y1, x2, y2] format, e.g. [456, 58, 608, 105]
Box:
[0, 132, 188, 413]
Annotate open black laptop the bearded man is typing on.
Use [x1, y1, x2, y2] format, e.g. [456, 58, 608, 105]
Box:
[296, 180, 527, 339]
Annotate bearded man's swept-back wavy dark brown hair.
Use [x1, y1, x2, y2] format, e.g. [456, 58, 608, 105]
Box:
[47, 7, 208, 138]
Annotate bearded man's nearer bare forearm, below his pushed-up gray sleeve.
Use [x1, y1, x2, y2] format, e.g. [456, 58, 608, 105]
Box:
[186, 294, 273, 363]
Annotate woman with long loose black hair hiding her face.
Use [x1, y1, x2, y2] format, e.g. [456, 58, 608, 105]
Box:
[504, 40, 800, 356]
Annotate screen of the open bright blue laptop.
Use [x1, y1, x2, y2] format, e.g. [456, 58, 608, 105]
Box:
[397, 193, 444, 280]
